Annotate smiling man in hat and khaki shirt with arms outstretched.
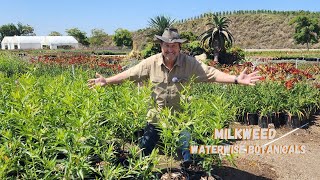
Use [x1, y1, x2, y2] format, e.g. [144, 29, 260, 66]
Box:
[88, 28, 260, 166]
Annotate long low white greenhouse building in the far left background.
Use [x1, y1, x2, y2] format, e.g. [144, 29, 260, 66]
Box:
[1, 36, 79, 49]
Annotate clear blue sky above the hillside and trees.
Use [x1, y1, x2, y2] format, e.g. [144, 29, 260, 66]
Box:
[0, 0, 320, 36]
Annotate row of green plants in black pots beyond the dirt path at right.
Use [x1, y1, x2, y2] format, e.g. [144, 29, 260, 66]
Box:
[197, 81, 320, 127]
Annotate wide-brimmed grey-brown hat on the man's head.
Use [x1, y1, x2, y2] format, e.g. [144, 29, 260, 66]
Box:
[155, 28, 187, 43]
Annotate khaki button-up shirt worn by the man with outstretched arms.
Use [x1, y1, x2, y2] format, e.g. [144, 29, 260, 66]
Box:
[128, 53, 220, 114]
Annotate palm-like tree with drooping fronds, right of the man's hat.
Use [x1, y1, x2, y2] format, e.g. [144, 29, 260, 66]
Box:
[199, 15, 234, 62]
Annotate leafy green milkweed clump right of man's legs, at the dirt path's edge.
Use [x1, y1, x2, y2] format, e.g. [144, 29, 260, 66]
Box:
[191, 94, 237, 179]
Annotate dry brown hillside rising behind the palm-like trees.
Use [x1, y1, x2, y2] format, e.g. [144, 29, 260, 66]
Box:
[133, 11, 320, 49]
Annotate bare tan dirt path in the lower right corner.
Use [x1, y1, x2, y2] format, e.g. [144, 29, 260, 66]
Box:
[216, 115, 320, 180]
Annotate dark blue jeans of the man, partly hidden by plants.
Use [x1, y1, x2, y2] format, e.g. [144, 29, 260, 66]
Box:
[139, 123, 191, 161]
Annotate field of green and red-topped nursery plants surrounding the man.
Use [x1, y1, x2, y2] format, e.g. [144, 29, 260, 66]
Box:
[0, 51, 320, 179]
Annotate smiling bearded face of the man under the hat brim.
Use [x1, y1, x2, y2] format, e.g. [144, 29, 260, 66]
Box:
[161, 42, 180, 61]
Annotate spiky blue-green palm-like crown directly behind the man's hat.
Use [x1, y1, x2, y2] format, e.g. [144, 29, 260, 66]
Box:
[149, 15, 175, 37]
